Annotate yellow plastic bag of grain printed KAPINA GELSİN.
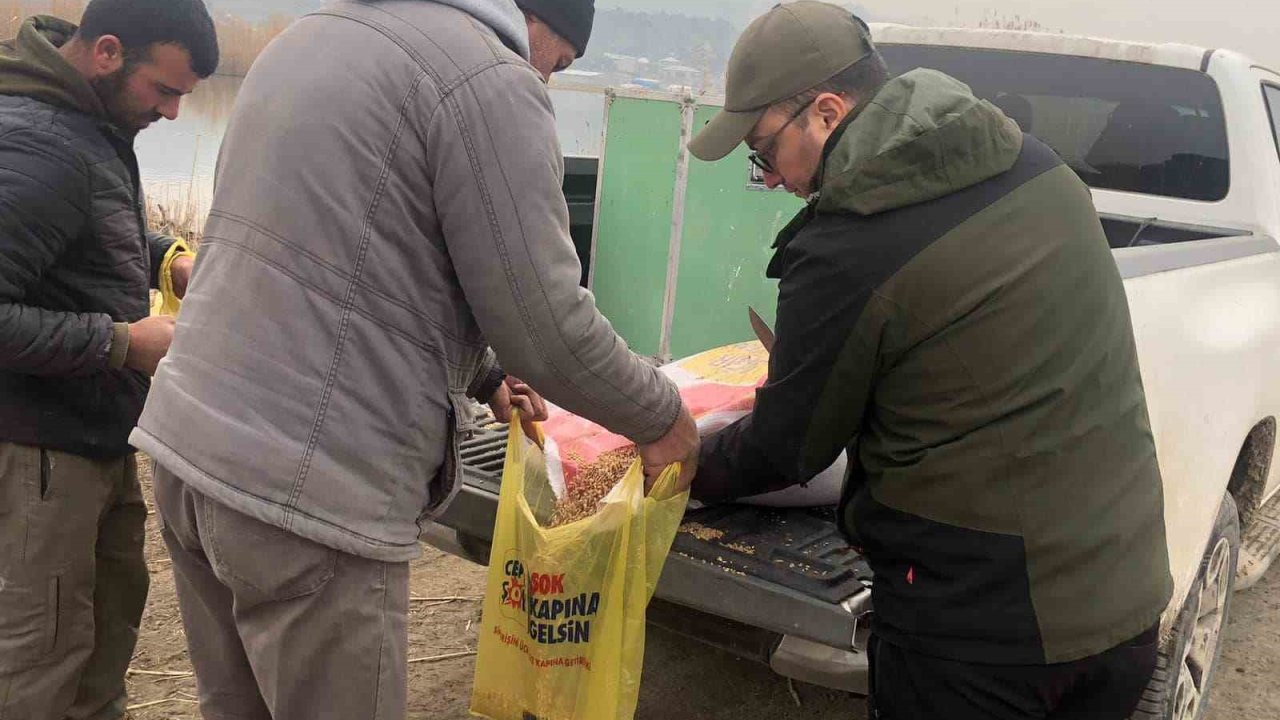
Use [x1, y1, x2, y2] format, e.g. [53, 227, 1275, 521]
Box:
[471, 412, 689, 720]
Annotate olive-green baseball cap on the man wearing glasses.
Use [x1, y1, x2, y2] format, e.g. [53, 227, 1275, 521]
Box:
[689, 0, 876, 161]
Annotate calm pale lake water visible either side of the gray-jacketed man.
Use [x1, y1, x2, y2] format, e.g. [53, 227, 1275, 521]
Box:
[136, 76, 604, 225]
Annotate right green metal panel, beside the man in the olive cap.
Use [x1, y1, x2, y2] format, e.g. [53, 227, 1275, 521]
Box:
[665, 108, 804, 357]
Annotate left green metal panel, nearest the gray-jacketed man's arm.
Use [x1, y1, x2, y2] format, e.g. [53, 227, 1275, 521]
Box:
[591, 92, 682, 355]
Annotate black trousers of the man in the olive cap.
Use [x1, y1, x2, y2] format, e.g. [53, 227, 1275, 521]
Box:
[869, 625, 1160, 720]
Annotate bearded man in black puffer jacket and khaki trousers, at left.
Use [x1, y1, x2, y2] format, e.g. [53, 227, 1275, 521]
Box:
[0, 0, 218, 720]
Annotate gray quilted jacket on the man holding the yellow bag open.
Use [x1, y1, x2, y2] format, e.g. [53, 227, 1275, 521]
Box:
[133, 0, 680, 561]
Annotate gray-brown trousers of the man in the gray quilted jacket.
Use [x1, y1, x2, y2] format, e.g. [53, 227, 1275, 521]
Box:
[155, 466, 408, 720]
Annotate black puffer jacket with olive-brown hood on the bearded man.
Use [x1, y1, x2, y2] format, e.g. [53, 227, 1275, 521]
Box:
[0, 18, 173, 457]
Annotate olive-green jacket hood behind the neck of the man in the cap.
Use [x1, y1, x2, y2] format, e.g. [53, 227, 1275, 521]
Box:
[817, 69, 1023, 215]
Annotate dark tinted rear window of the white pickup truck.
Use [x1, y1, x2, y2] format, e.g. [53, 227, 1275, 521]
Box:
[881, 44, 1230, 201]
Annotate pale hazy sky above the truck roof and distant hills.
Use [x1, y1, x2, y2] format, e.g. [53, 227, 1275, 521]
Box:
[596, 0, 1280, 69]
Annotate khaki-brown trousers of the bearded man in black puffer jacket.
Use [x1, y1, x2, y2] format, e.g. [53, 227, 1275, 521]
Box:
[0, 443, 148, 720]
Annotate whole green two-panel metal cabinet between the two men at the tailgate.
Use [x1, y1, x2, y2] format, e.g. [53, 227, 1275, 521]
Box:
[589, 92, 803, 361]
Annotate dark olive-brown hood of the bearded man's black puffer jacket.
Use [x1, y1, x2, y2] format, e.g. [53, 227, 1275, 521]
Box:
[0, 15, 108, 120]
